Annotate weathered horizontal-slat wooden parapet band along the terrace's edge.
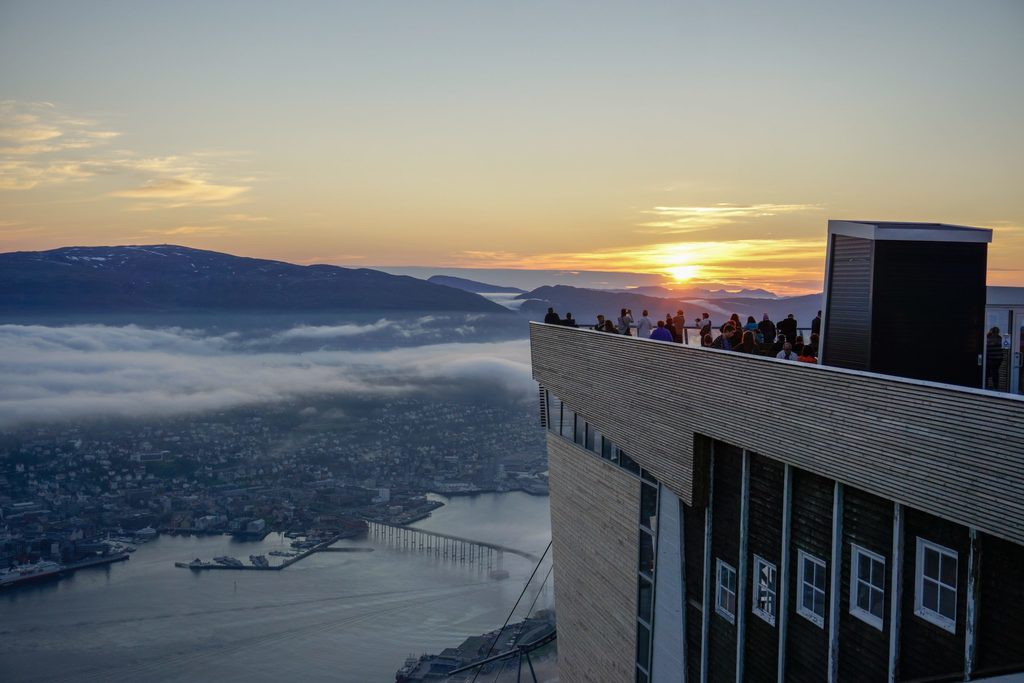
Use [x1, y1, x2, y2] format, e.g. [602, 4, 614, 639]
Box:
[530, 324, 1024, 544]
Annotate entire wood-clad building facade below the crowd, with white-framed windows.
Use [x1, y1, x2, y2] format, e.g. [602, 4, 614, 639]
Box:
[530, 317, 1024, 682]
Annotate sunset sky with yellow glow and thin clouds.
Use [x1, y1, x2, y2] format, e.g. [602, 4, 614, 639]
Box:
[0, 0, 1024, 294]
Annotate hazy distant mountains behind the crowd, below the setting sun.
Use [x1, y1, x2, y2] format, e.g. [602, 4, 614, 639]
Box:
[517, 285, 821, 327]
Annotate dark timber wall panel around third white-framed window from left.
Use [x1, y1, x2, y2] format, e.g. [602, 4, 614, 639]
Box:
[785, 470, 835, 683]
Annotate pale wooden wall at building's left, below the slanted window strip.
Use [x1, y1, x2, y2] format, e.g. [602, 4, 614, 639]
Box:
[548, 433, 640, 683]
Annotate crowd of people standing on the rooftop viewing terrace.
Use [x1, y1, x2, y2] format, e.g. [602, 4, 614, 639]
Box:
[544, 308, 821, 362]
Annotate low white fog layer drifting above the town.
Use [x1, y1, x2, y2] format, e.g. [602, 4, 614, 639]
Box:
[0, 318, 537, 427]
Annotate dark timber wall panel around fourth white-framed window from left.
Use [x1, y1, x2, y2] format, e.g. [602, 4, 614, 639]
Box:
[839, 486, 893, 681]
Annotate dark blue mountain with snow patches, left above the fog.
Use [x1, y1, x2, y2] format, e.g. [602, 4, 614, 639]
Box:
[0, 245, 508, 313]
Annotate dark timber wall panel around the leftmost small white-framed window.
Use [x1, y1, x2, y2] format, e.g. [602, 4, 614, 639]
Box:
[708, 441, 743, 681]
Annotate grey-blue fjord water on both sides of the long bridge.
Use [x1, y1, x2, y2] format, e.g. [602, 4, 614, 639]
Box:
[0, 493, 553, 682]
